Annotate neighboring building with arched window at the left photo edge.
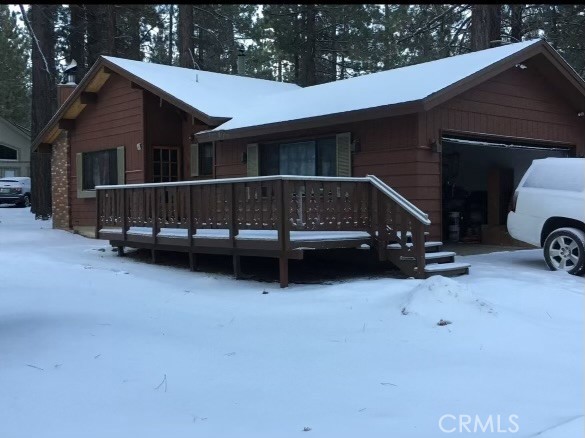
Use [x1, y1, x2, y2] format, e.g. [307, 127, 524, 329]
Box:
[0, 117, 30, 178]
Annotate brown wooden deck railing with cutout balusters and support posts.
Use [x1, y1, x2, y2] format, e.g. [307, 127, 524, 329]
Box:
[96, 175, 430, 285]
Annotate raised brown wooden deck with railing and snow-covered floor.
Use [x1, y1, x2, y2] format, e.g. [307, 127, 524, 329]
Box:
[96, 176, 468, 287]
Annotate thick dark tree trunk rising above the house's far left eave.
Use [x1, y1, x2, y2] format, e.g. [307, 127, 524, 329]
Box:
[29, 4, 58, 138]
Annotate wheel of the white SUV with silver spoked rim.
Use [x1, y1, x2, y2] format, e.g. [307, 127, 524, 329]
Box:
[544, 228, 585, 275]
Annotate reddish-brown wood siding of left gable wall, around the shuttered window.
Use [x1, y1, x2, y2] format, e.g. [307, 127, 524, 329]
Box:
[69, 74, 144, 226]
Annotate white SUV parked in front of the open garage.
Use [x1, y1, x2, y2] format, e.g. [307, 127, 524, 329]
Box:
[508, 158, 585, 275]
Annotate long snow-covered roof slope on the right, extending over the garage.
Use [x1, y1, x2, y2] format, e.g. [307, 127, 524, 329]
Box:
[207, 39, 541, 132]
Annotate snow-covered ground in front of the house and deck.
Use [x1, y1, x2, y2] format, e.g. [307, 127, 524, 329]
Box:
[0, 207, 584, 438]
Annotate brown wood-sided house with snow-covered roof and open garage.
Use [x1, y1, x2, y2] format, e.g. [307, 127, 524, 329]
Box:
[33, 40, 585, 241]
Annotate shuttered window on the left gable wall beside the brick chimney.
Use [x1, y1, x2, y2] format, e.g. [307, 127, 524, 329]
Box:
[76, 146, 125, 198]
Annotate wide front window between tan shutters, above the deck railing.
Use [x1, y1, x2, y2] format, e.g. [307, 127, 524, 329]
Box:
[260, 137, 337, 176]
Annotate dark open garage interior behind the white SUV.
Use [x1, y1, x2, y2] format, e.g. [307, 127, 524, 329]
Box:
[441, 135, 574, 246]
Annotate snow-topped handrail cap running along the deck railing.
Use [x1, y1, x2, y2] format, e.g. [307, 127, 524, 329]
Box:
[95, 175, 431, 225]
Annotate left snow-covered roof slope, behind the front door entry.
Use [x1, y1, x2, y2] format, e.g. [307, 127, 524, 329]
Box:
[104, 56, 300, 118]
